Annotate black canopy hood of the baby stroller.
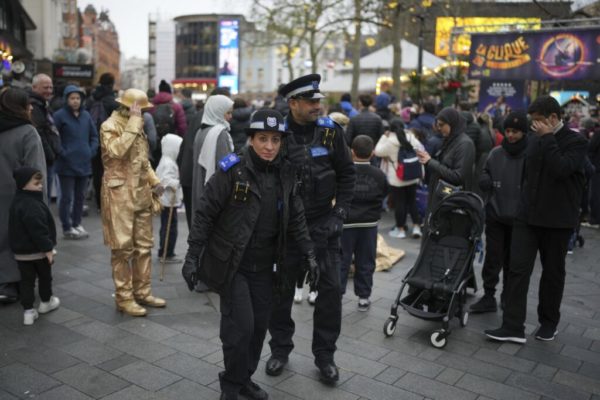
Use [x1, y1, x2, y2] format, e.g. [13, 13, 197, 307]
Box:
[429, 192, 485, 239]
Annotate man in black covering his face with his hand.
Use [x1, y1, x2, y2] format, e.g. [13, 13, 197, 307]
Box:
[485, 96, 587, 344]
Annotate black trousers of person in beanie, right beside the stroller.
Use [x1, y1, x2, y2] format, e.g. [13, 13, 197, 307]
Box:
[481, 218, 512, 296]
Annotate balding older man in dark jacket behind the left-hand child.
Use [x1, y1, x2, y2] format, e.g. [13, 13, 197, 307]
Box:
[29, 74, 61, 199]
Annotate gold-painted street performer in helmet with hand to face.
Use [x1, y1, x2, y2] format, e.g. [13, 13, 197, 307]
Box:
[100, 89, 166, 316]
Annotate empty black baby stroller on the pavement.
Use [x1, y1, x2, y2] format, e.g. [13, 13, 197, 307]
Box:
[383, 192, 485, 348]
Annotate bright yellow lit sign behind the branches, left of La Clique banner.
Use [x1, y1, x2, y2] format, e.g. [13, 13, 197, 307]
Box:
[435, 17, 541, 57]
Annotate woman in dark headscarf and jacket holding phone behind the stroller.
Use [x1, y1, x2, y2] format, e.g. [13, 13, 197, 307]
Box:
[417, 107, 475, 210]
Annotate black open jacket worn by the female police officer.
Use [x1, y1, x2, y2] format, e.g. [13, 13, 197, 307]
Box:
[188, 149, 313, 293]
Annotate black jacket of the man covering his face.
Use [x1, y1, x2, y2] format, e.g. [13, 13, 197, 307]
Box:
[517, 126, 588, 229]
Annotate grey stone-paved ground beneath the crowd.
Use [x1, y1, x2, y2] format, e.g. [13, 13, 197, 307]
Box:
[0, 206, 600, 400]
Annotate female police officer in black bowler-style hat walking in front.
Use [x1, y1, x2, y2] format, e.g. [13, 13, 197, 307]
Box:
[182, 110, 318, 400]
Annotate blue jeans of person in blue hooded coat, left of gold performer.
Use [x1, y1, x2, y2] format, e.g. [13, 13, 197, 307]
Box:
[58, 175, 89, 232]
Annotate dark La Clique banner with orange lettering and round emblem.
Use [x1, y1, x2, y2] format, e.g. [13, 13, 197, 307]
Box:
[469, 28, 600, 80]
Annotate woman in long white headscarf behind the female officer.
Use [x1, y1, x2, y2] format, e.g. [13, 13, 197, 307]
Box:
[192, 94, 233, 215]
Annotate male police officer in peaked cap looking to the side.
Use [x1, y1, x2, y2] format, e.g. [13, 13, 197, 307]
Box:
[266, 74, 355, 384]
